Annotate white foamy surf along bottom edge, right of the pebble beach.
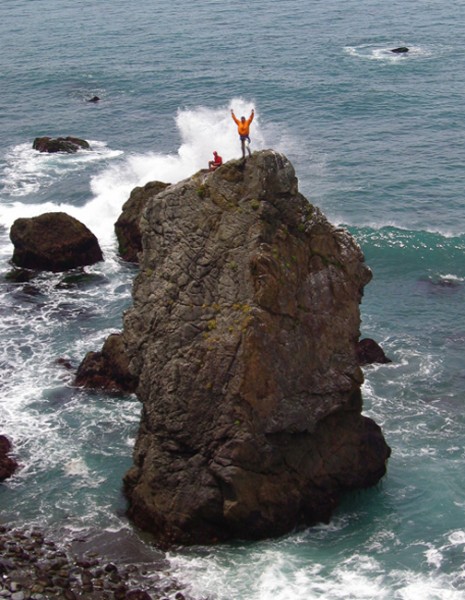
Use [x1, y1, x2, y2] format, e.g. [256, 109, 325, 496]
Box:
[167, 542, 463, 600]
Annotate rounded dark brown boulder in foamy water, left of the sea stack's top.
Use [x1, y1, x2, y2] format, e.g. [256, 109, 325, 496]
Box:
[10, 212, 103, 272]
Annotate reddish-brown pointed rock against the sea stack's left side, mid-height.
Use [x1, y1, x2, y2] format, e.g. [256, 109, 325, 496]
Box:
[74, 333, 137, 392]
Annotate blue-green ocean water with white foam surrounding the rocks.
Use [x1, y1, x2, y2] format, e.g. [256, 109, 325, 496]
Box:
[0, 0, 465, 600]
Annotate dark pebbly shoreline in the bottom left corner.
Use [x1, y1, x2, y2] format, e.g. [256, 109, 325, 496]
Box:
[0, 525, 206, 600]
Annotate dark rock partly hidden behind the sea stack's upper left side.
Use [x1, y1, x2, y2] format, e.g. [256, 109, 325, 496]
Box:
[115, 181, 169, 262]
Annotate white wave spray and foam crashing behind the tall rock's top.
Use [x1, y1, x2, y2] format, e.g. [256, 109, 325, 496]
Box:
[0, 98, 280, 249]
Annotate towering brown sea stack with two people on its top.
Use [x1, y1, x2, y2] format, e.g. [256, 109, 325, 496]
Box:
[124, 150, 390, 544]
